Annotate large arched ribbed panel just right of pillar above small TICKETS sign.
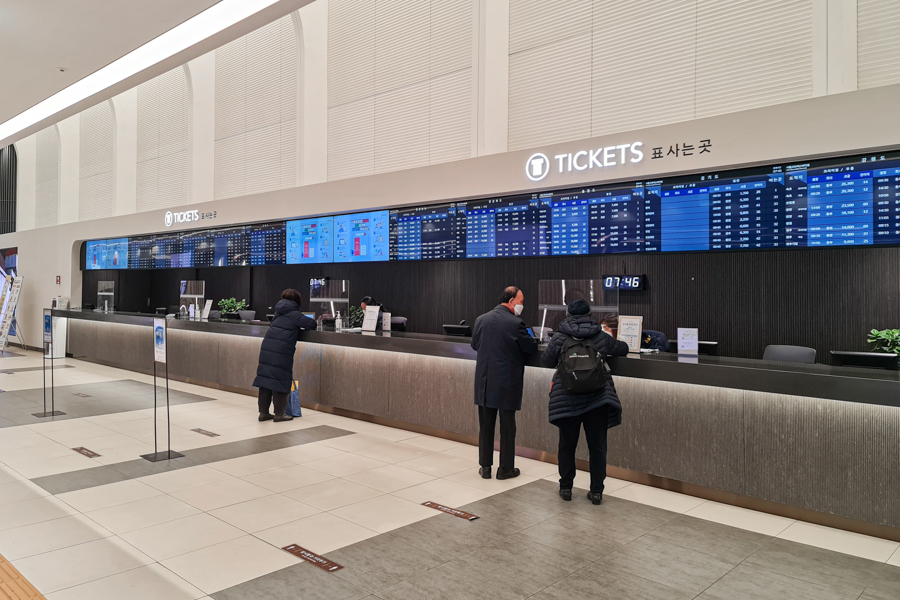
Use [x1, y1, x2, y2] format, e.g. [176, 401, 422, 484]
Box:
[215, 15, 298, 199]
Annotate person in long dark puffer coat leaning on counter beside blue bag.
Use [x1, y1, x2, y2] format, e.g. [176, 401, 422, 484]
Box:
[253, 289, 316, 421]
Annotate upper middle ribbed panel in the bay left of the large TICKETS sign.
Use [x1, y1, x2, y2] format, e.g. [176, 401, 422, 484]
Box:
[375, 0, 431, 94]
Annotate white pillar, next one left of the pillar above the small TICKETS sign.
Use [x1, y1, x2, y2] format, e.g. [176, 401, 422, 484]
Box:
[112, 88, 137, 215]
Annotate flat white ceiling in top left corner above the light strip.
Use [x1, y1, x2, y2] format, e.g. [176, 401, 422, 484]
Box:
[0, 0, 219, 123]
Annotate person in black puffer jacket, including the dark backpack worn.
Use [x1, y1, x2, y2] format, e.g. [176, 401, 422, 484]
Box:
[541, 299, 628, 504]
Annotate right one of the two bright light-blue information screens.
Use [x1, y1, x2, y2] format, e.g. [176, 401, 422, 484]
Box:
[334, 210, 391, 262]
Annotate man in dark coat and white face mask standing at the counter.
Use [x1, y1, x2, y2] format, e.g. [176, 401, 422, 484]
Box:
[472, 286, 537, 479]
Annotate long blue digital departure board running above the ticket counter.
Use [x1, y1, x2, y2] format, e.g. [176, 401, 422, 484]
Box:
[84, 152, 900, 269]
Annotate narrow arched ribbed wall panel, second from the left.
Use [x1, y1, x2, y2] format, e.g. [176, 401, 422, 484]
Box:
[78, 101, 116, 221]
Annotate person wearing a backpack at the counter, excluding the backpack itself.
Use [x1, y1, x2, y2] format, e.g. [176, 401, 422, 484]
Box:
[541, 300, 628, 504]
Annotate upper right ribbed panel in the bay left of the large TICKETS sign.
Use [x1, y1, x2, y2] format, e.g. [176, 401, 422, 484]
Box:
[429, 0, 474, 77]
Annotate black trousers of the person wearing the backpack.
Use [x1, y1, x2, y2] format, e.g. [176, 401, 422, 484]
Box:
[553, 407, 607, 494]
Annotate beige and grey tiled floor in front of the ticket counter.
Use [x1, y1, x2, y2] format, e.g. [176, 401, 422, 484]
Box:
[0, 353, 900, 600]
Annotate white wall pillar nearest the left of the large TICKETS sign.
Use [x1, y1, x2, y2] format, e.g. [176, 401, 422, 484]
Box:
[473, 0, 509, 156]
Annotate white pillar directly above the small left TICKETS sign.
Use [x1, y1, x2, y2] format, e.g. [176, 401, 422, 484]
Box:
[185, 52, 216, 203]
